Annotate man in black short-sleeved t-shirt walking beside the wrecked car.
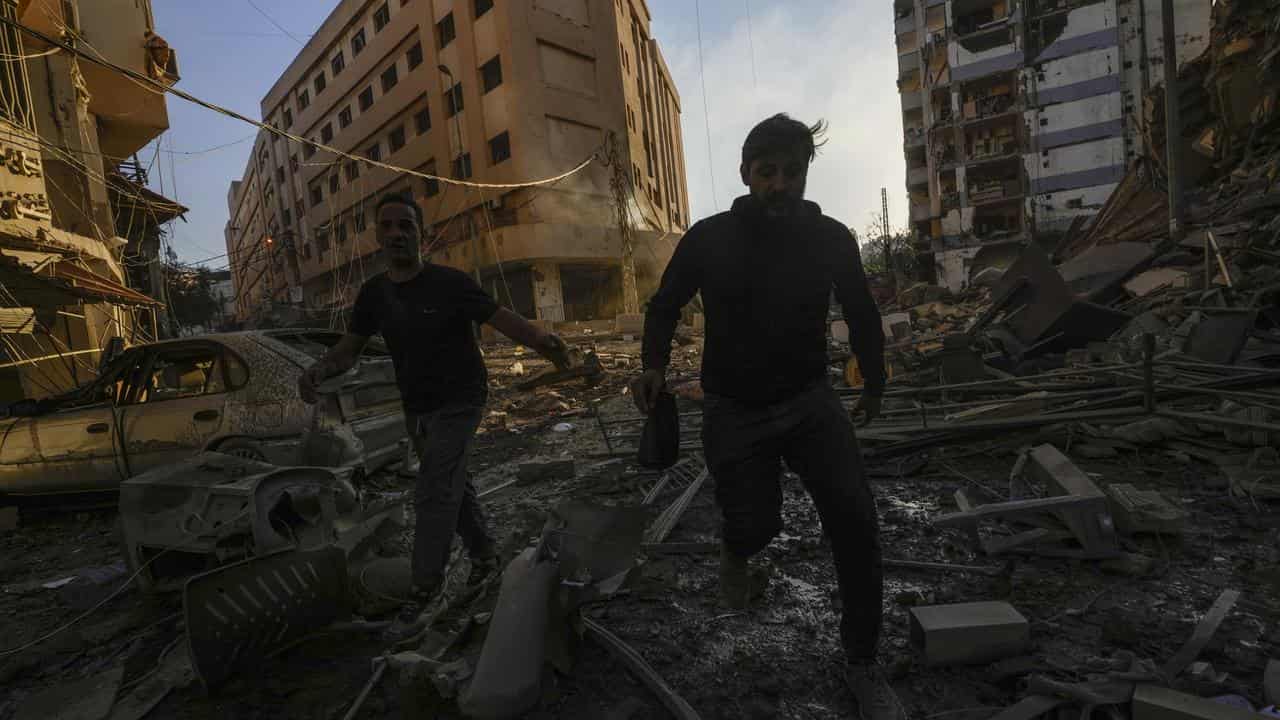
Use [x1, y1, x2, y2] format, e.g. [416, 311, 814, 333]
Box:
[298, 189, 568, 600]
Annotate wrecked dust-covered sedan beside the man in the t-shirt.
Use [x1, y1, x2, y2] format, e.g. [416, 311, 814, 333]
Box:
[0, 329, 406, 496]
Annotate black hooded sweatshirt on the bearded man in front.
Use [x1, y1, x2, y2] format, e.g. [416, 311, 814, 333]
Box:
[641, 195, 884, 405]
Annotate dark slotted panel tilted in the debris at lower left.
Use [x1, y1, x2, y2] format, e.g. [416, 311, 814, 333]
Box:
[182, 547, 351, 689]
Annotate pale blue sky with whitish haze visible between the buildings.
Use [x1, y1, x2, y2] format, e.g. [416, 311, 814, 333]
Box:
[141, 0, 906, 266]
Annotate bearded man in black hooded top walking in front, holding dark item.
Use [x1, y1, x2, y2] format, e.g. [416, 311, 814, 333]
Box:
[631, 114, 901, 720]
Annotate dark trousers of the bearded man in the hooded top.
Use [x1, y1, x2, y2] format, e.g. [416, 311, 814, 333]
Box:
[703, 383, 883, 661]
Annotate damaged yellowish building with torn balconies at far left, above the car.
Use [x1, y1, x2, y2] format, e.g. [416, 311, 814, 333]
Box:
[0, 0, 186, 399]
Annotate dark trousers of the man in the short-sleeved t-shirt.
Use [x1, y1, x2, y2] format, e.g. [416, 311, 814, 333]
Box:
[406, 405, 494, 588]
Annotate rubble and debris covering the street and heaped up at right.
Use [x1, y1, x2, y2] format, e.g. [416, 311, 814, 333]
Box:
[0, 0, 1280, 720]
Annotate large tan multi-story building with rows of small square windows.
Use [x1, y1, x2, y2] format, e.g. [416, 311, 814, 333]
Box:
[227, 0, 689, 327]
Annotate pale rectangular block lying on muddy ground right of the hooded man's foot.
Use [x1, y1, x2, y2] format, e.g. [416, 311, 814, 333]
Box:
[911, 602, 1030, 665]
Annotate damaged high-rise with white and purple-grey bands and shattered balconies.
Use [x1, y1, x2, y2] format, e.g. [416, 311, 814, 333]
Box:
[893, 0, 1210, 291]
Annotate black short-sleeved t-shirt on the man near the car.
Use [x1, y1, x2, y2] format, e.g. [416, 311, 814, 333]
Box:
[351, 264, 498, 413]
